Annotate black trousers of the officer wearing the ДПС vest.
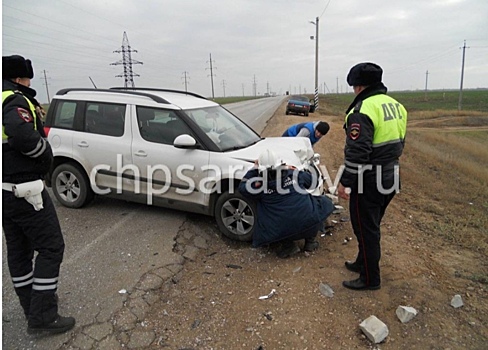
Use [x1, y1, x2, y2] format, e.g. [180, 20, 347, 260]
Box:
[349, 182, 395, 286]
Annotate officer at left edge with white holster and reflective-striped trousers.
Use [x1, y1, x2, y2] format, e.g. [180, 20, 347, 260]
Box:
[2, 55, 75, 333]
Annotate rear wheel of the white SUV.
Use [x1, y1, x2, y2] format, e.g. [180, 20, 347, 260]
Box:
[51, 163, 94, 208]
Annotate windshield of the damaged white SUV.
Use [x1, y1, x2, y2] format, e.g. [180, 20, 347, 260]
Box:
[184, 106, 261, 151]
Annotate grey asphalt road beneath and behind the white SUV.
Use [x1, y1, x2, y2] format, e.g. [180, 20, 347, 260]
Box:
[2, 96, 283, 349]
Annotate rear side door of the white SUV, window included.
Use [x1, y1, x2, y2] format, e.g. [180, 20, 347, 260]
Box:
[73, 102, 133, 195]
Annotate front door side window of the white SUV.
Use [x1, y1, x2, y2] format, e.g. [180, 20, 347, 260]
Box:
[136, 106, 191, 145]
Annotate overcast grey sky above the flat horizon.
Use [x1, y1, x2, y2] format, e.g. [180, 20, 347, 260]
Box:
[2, 0, 488, 102]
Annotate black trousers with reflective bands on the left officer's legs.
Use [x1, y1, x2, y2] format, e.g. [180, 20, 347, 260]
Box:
[2, 190, 64, 326]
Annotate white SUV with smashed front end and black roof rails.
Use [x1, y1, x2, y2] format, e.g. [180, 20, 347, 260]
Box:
[45, 88, 323, 241]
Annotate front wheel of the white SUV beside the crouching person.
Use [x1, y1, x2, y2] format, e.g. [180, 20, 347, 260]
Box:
[215, 191, 257, 242]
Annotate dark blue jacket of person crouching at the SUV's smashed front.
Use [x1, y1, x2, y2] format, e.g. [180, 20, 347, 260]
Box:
[239, 169, 334, 247]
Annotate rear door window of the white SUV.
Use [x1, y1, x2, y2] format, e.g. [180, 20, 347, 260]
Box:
[85, 102, 126, 137]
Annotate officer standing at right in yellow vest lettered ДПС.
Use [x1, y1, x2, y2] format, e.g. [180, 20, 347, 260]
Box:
[338, 62, 407, 290]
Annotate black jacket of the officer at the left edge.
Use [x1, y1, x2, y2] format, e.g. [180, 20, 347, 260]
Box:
[2, 80, 53, 183]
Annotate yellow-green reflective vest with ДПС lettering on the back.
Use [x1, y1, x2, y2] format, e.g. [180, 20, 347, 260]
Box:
[346, 94, 407, 147]
